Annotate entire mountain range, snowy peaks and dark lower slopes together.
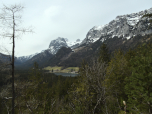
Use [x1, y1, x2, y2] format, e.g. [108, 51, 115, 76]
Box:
[9, 8, 152, 67]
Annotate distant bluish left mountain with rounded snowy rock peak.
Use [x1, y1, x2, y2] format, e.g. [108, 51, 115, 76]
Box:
[15, 37, 81, 66]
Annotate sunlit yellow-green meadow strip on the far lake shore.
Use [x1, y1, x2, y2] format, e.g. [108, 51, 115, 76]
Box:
[44, 66, 79, 73]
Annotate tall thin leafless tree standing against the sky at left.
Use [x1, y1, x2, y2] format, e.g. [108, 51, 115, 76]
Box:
[0, 4, 33, 114]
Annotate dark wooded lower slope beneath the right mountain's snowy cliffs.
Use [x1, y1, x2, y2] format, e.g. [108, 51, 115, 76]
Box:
[46, 34, 152, 67]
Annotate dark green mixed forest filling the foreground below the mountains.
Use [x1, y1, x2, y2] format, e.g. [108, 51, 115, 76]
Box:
[0, 43, 152, 114]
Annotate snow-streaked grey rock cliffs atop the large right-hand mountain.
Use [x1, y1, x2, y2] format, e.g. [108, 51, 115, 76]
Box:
[80, 8, 152, 45]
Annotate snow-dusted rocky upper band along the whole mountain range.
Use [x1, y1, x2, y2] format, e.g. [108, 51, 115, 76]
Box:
[17, 8, 152, 62]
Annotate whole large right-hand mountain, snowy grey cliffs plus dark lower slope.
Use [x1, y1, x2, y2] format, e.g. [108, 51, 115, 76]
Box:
[48, 8, 152, 66]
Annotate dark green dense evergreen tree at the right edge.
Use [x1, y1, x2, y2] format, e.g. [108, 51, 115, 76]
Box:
[125, 44, 152, 114]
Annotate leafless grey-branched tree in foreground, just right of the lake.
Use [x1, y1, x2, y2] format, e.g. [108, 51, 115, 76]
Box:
[85, 58, 108, 114]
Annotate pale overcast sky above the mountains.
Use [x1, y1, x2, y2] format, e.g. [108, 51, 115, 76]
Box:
[0, 0, 152, 57]
